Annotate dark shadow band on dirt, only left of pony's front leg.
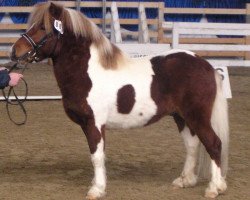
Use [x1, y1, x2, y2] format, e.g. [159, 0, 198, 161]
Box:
[0, 160, 93, 186]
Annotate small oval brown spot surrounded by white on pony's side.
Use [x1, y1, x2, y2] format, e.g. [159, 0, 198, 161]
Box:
[117, 85, 135, 114]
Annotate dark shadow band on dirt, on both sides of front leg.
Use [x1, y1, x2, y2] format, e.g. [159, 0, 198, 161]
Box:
[0, 158, 182, 186]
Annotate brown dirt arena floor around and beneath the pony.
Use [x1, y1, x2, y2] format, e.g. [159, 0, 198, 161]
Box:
[0, 64, 250, 200]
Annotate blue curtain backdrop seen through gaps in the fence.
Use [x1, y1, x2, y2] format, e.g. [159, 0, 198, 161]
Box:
[0, 0, 246, 24]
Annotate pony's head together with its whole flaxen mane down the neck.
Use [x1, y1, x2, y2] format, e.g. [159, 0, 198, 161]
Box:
[11, 2, 123, 68]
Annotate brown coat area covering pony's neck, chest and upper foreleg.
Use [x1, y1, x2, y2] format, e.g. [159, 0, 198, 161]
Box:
[53, 33, 104, 154]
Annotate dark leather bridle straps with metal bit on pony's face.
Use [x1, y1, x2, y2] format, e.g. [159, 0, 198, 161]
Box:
[18, 32, 60, 62]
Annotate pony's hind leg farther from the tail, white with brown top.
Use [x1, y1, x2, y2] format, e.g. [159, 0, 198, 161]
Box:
[173, 116, 200, 188]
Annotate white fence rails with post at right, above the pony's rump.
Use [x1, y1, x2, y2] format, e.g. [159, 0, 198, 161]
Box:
[163, 22, 250, 56]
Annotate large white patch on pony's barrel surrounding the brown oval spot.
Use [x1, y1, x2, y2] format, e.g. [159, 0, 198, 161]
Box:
[87, 45, 157, 130]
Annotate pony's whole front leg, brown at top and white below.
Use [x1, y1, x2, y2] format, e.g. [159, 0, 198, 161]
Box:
[82, 119, 106, 199]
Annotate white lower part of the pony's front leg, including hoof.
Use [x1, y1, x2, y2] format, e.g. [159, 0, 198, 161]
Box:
[88, 139, 106, 198]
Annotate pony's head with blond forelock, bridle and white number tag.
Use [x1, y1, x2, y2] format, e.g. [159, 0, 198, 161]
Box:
[11, 3, 66, 62]
